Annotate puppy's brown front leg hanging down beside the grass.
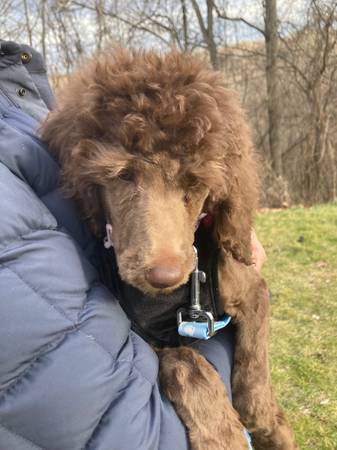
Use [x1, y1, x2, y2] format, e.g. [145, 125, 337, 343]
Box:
[219, 254, 298, 450]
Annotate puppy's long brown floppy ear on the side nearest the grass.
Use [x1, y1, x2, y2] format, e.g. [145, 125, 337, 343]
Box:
[213, 92, 259, 265]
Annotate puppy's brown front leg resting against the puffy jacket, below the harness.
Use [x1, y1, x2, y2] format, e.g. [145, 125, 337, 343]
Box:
[158, 347, 248, 450]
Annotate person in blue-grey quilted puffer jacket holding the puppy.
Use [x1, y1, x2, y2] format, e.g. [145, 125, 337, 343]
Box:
[0, 41, 238, 450]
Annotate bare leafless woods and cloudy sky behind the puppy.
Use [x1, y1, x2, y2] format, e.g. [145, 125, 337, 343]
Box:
[0, 0, 337, 207]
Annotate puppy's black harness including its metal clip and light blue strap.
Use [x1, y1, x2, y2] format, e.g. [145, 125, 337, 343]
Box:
[101, 223, 230, 347]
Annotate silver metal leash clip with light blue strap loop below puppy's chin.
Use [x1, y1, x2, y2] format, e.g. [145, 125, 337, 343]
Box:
[177, 246, 215, 339]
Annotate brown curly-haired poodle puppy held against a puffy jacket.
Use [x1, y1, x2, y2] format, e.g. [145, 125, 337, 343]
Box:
[43, 49, 298, 450]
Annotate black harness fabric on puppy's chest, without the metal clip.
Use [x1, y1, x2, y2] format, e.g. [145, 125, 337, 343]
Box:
[100, 229, 224, 348]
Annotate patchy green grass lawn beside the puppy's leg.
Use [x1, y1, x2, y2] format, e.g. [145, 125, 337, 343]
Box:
[256, 204, 337, 450]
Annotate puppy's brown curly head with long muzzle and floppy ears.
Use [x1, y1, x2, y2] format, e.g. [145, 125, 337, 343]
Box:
[42, 50, 257, 294]
